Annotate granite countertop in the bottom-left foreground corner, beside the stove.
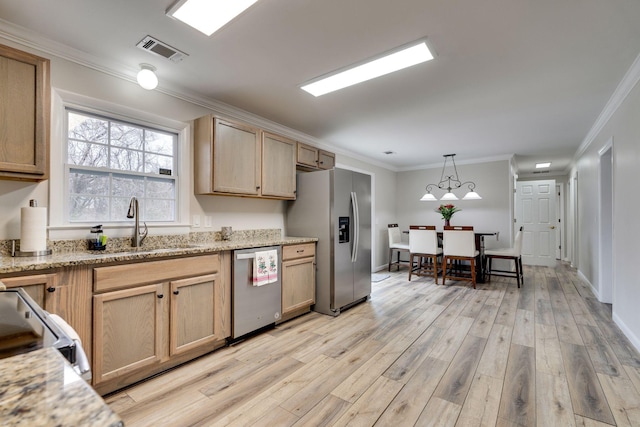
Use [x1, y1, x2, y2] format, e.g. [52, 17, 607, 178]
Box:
[0, 347, 124, 427]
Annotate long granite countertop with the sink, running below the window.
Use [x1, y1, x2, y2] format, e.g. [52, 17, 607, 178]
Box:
[0, 237, 318, 274]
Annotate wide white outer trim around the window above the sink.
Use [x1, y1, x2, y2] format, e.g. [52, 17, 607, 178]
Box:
[48, 89, 191, 240]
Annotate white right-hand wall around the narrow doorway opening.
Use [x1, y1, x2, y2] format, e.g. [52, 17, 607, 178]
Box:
[572, 64, 640, 349]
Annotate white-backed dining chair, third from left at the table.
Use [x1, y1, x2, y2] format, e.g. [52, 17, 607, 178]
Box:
[442, 226, 479, 289]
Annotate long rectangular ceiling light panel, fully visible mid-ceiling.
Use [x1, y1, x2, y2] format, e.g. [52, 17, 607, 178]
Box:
[301, 41, 433, 96]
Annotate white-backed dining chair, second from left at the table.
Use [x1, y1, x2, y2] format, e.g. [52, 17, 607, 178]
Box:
[409, 225, 442, 285]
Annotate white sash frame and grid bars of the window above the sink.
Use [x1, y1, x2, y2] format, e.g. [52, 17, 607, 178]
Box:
[63, 106, 180, 226]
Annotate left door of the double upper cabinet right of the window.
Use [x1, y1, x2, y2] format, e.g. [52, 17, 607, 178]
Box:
[213, 119, 261, 195]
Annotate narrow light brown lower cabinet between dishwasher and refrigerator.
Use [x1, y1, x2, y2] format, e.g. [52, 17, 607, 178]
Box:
[282, 243, 316, 321]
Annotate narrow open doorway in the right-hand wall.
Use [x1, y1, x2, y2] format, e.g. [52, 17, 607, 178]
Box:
[598, 143, 614, 304]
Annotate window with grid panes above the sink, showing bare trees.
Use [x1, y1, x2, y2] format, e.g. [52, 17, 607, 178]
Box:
[66, 109, 178, 222]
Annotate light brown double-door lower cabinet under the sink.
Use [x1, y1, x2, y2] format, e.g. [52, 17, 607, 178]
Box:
[93, 252, 231, 394]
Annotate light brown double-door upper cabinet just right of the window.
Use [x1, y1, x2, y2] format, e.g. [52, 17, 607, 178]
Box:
[193, 115, 296, 199]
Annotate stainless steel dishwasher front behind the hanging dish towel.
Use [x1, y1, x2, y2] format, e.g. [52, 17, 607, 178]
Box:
[231, 246, 282, 340]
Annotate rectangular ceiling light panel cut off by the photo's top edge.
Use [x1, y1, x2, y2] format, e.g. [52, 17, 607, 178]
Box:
[167, 0, 258, 36]
